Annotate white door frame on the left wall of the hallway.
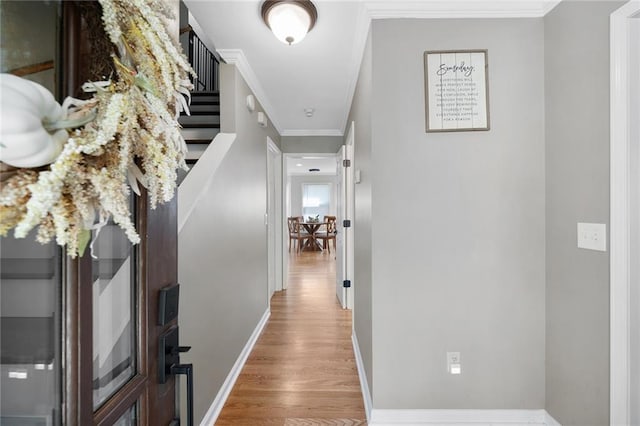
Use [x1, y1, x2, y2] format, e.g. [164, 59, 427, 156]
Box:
[266, 136, 284, 305]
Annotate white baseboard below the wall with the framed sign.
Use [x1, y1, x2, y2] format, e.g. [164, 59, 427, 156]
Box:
[369, 408, 560, 426]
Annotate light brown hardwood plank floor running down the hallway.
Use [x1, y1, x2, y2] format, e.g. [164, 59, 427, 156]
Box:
[216, 251, 366, 426]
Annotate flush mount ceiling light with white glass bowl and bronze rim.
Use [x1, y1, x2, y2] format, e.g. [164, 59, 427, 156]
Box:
[262, 0, 318, 45]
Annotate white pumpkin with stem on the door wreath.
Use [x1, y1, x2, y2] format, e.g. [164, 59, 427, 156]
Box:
[0, 74, 69, 167]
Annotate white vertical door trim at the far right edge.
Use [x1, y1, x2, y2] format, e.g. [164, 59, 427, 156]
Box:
[609, 0, 640, 425]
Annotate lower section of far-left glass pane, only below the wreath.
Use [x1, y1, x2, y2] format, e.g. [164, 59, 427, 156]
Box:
[0, 233, 62, 426]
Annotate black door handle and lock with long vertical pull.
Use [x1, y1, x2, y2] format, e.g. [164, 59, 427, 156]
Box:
[158, 327, 193, 426]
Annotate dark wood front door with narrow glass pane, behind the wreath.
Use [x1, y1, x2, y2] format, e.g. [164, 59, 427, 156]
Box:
[60, 1, 178, 426]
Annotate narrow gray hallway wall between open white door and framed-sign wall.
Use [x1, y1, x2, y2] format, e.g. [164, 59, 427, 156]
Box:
[344, 28, 374, 393]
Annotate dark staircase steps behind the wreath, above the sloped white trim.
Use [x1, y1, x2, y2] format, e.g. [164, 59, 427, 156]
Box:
[178, 91, 220, 183]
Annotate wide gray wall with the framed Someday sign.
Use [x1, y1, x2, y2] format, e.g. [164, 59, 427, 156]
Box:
[354, 19, 545, 409]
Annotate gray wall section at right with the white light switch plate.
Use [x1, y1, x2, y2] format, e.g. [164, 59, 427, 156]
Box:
[544, 1, 622, 425]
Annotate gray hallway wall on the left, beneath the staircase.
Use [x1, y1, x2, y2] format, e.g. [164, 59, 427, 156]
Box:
[179, 65, 280, 424]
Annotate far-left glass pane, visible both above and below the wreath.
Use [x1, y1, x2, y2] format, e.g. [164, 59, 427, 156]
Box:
[0, 0, 63, 426]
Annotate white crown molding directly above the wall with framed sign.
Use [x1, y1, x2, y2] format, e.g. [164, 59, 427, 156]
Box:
[364, 0, 560, 19]
